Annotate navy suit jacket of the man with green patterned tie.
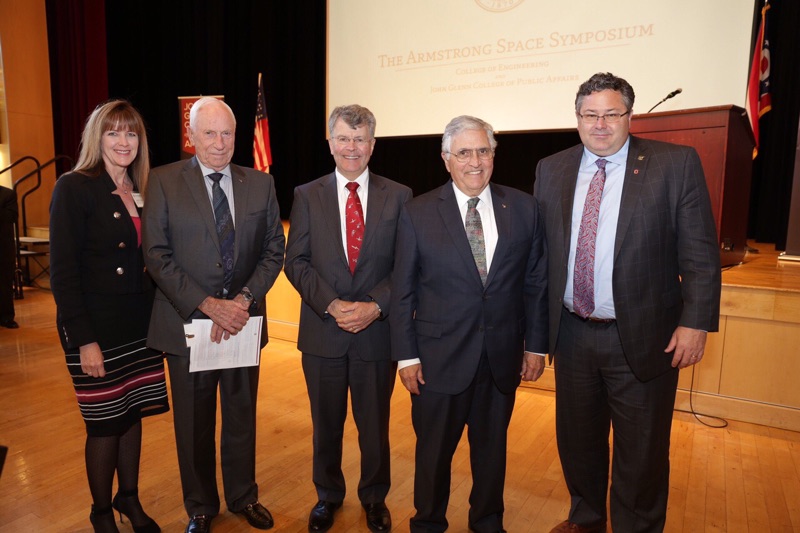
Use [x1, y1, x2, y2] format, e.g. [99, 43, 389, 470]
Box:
[390, 182, 547, 394]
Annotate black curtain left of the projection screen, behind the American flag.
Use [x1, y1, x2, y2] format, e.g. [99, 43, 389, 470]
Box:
[106, 0, 331, 218]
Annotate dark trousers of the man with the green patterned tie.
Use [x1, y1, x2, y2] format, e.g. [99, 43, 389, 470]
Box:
[411, 352, 516, 533]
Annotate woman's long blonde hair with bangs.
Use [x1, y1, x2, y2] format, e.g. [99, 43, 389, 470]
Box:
[72, 100, 150, 196]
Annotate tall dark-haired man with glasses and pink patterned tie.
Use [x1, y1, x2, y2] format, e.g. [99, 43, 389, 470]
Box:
[534, 74, 720, 532]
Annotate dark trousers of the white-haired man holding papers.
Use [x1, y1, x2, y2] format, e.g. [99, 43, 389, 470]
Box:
[167, 354, 259, 516]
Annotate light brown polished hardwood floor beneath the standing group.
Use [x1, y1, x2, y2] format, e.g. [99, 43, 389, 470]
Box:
[0, 288, 800, 533]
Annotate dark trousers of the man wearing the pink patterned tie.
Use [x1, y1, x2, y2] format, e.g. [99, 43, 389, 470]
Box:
[554, 309, 678, 532]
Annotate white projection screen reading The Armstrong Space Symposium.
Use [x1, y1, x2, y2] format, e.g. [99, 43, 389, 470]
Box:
[326, 0, 754, 136]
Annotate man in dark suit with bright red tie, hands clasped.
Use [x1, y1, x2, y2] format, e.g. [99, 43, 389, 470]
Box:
[284, 105, 411, 532]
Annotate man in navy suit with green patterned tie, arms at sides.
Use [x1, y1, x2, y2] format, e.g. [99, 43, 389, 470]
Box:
[390, 116, 547, 533]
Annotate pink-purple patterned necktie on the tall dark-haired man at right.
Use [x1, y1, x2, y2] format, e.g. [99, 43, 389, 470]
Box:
[572, 159, 607, 318]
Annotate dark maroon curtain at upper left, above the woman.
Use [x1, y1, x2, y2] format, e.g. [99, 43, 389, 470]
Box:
[42, 0, 108, 175]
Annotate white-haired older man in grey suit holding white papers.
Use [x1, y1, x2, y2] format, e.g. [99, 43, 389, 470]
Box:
[143, 98, 284, 533]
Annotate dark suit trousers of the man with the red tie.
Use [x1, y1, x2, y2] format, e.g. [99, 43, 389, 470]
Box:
[303, 349, 397, 504]
